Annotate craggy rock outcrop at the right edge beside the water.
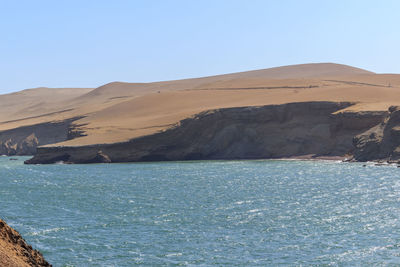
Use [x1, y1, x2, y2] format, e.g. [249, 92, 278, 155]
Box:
[354, 106, 400, 161]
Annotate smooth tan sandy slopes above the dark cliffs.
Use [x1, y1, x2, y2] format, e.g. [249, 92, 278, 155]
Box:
[0, 63, 400, 145]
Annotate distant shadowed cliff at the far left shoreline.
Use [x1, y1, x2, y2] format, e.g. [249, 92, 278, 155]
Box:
[0, 117, 83, 156]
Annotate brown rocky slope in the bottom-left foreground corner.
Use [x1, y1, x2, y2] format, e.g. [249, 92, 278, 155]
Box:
[0, 220, 51, 267]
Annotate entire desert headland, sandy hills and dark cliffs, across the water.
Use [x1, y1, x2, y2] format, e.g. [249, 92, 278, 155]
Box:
[0, 63, 400, 164]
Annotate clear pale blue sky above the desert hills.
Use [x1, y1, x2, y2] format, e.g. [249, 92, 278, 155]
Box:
[0, 0, 400, 93]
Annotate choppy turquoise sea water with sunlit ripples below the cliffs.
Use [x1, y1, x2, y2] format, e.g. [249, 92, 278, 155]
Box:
[0, 157, 400, 266]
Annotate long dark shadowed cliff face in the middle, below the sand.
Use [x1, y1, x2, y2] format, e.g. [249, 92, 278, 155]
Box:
[26, 102, 386, 164]
